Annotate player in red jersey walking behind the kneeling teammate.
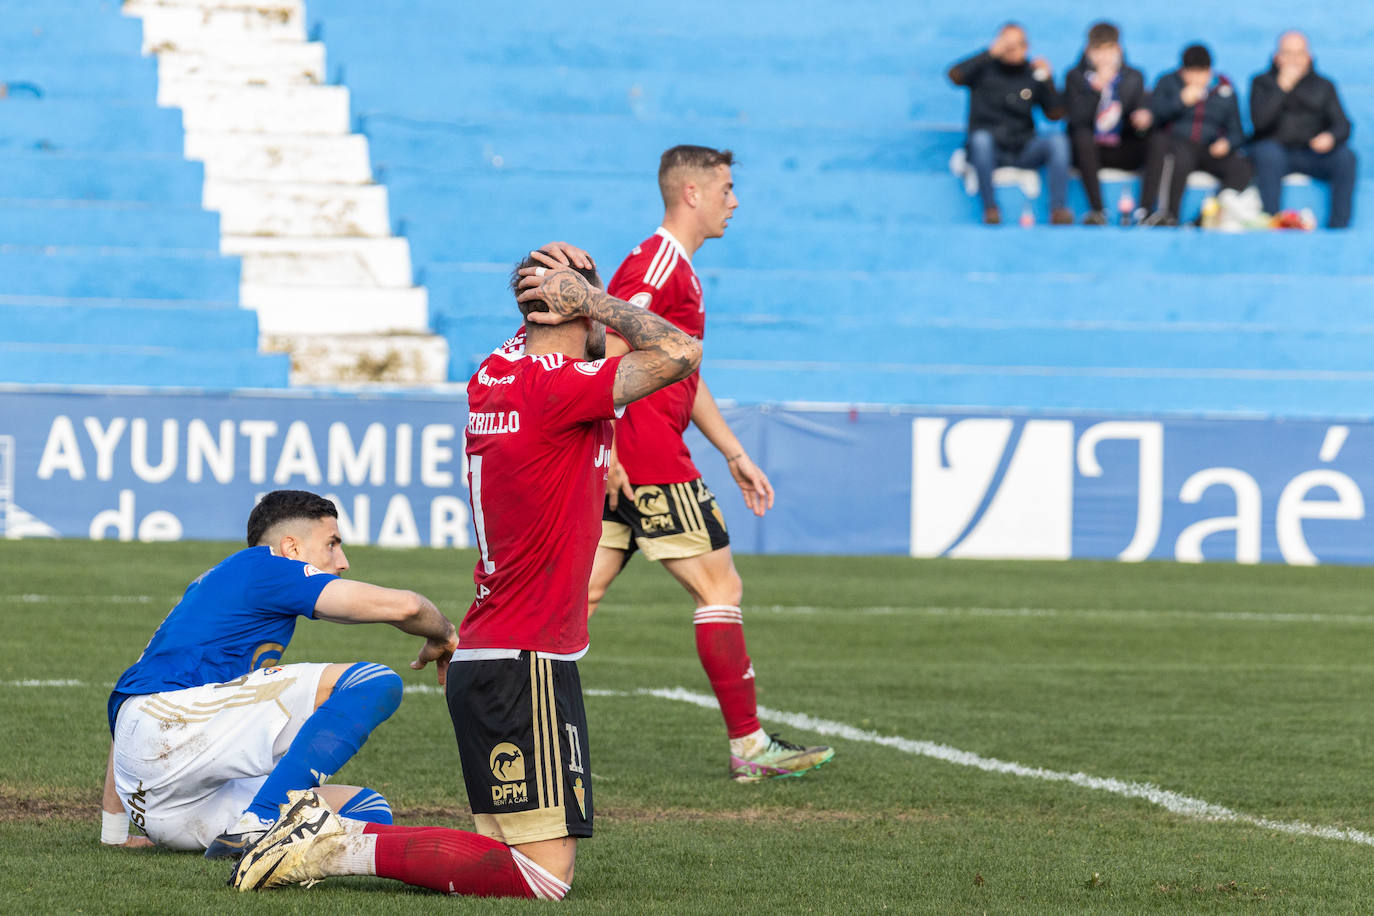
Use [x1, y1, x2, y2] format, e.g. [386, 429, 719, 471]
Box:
[587, 146, 834, 783]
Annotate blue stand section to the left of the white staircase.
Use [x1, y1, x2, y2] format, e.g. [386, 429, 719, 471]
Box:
[0, 0, 289, 387]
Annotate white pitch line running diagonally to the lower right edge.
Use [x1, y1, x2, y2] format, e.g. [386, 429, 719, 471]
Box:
[585, 687, 1374, 846]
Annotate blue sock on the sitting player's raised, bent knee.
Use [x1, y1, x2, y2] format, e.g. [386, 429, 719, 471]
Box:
[247, 662, 401, 821]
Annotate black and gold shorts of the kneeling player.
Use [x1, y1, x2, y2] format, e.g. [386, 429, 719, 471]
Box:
[445, 652, 592, 846]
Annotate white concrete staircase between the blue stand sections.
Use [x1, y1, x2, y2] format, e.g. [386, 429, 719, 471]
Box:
[124, 0, 448, 385]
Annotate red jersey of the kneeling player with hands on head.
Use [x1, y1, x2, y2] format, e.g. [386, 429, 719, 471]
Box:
[458, 335, 620, 655]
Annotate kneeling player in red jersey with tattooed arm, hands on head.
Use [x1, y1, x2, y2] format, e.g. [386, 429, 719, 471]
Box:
[231, 244, 701, 900]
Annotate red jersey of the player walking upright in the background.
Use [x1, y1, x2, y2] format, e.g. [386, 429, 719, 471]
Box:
[606, 227, 706, 485]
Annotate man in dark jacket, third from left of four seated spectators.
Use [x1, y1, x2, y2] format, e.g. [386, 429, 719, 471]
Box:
[1140, 44, 1250, 225]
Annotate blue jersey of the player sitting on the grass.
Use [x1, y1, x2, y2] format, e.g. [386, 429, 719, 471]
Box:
[109, 547, 338, 733]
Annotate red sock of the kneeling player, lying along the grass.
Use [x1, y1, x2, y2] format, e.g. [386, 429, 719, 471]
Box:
[364, 824, 534, 897]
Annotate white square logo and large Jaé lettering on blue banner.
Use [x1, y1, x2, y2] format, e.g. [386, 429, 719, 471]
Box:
[911, 416, 1369, 564]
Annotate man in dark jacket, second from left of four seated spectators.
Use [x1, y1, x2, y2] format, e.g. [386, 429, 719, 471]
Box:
[1063, 22, 1154, 225]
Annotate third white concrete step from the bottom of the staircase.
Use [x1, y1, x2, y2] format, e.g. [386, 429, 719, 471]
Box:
[220, 235, 415, 288]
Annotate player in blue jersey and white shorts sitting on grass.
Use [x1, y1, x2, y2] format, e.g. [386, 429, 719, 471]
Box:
[100, 490, 458, 858]
